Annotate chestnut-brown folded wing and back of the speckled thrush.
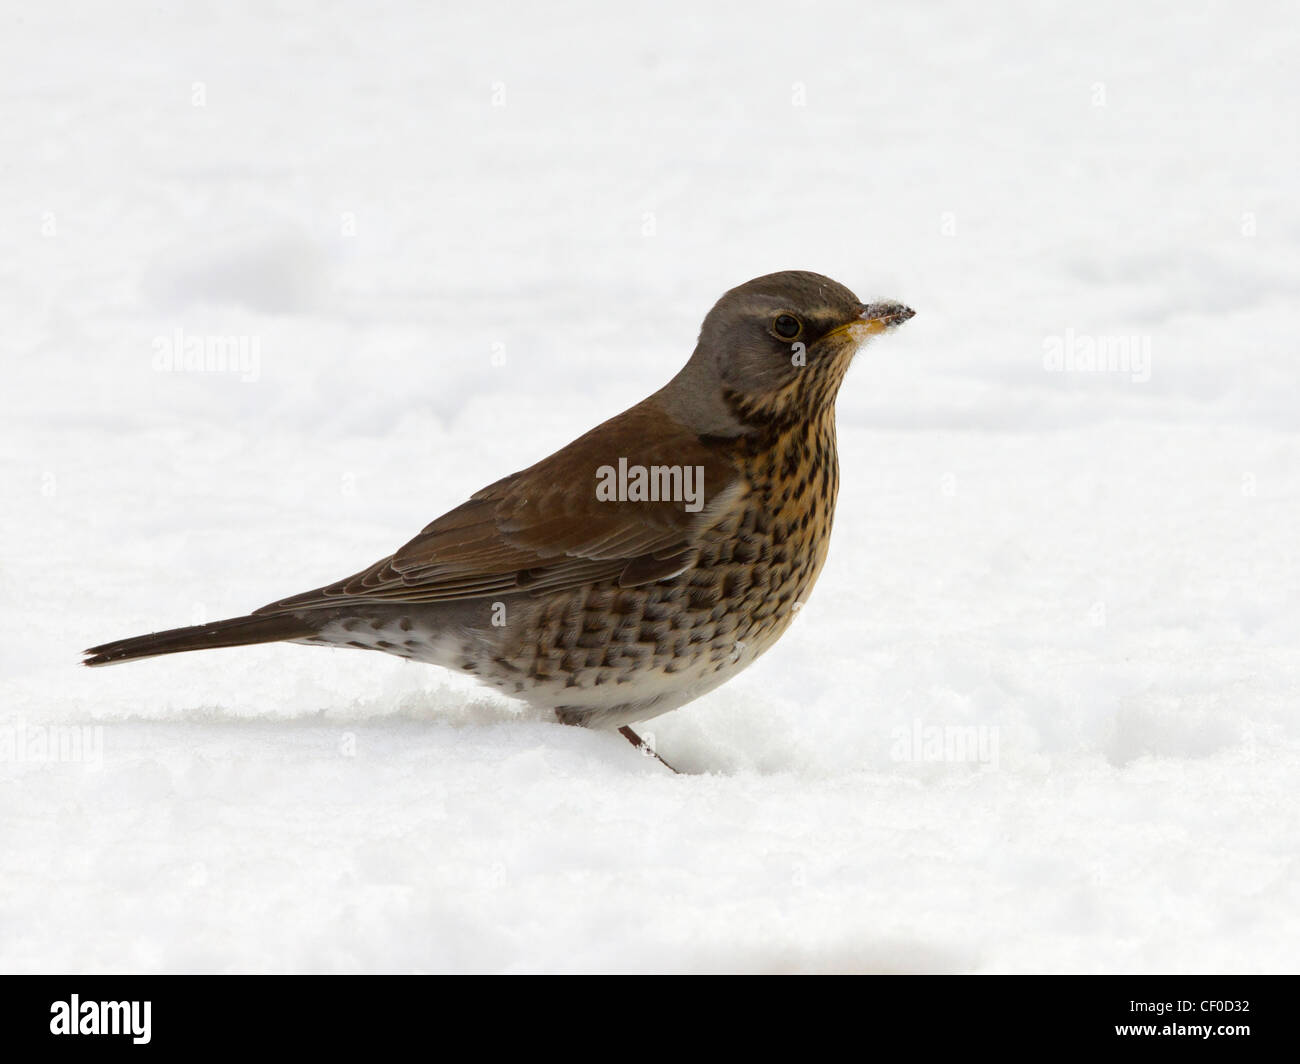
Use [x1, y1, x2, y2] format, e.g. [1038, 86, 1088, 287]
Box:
[256, 397, 742, 614]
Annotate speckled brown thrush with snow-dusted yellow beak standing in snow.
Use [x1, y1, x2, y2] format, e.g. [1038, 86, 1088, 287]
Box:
[83, 271, 914, 767]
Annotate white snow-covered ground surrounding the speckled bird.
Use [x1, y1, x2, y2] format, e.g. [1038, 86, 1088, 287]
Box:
[0, 0, 1300, 972]
